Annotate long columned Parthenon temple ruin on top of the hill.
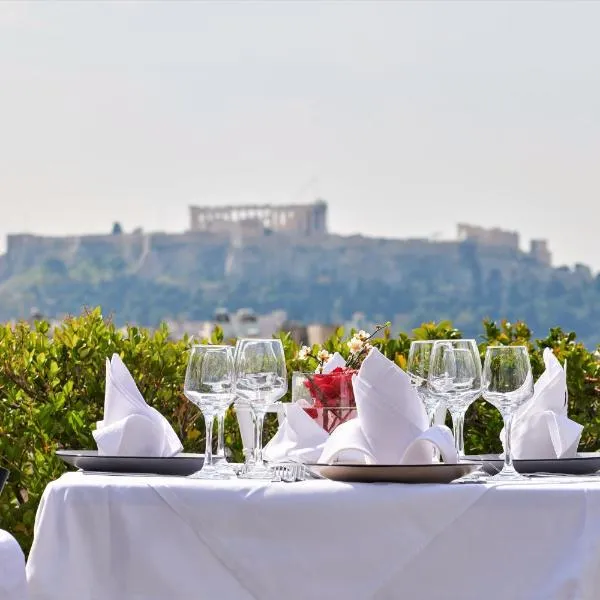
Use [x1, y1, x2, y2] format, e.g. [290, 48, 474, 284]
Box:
[190, 200, 327, 235]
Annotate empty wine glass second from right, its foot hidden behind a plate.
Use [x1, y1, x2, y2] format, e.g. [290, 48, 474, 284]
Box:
[427, 340, 481, 458]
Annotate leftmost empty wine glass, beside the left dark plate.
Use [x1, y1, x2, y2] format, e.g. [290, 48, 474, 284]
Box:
[184, 345, 234, 479]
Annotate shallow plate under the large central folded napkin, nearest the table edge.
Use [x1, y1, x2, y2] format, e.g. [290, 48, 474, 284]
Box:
[307, 462, 481, 483]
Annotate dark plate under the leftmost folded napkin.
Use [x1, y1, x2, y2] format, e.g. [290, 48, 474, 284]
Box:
[56, 450, 204, 475]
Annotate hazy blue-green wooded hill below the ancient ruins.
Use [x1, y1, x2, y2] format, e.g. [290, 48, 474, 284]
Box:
[0, 231, 600, 347]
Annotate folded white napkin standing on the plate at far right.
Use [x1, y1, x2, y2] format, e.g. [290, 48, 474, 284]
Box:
[500, 348, 583, 459]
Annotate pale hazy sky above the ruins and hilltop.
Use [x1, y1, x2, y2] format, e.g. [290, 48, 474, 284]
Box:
[0, 0, 600, 269]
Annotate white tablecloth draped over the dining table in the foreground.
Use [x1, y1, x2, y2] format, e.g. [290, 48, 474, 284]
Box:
[27, 473, 600, 600]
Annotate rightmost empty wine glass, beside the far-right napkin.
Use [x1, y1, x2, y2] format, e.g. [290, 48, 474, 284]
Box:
[483, 346, 533, 481]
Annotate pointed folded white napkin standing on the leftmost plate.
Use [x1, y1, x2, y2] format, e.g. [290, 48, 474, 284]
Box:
[92, 354, 183, 457]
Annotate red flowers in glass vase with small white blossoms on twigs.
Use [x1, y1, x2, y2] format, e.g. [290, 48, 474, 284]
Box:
[298, 322, 390, 433]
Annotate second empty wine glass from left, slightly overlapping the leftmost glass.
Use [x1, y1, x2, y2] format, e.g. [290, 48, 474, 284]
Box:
[235, 339, 287, 480]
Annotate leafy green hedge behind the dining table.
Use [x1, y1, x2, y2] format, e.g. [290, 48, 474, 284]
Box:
[0, 310, 600, 550]
